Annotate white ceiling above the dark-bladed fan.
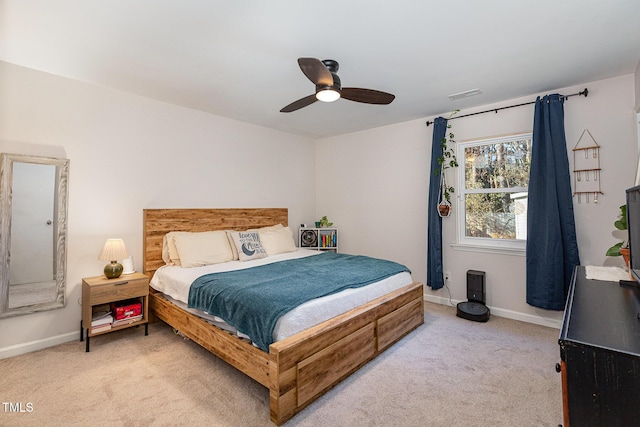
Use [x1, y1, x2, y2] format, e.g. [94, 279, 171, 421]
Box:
[0, 0, 640, 138]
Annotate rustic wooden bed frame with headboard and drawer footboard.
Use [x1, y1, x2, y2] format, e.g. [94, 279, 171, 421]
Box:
[143, 208, 424, 425]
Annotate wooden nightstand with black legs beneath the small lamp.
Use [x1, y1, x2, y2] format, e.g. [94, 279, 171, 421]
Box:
[80, 272, 149, 352]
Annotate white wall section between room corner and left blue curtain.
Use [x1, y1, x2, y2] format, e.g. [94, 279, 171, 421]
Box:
[316, 119, 431, 283]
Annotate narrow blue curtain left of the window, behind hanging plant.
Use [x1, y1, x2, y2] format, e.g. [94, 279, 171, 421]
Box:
[427, 117, 447, 290]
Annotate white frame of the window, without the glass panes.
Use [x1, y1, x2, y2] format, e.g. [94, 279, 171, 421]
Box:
[453, 132, 533, 255]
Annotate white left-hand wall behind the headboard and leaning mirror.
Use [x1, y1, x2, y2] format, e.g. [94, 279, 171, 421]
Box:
[0, 62, 315, 357]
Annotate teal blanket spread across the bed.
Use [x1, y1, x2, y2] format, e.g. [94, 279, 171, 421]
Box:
[189, 252, 410, 352]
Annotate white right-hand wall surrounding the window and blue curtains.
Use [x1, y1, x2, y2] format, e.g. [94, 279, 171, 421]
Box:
[316, 75, 637, 326]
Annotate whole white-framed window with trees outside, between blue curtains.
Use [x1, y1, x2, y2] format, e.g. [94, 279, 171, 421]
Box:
[457, 133, 531, 250]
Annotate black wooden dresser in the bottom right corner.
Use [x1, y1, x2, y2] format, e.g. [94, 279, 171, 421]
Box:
[559, 266, 640, 427]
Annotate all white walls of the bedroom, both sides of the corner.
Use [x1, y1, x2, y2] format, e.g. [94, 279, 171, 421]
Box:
[0, 58, 637, 357]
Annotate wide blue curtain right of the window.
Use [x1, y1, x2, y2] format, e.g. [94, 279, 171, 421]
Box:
[527, 94, 580, 310]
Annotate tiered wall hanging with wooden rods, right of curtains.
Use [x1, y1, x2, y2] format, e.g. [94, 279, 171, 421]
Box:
[573, 129, 603, 203]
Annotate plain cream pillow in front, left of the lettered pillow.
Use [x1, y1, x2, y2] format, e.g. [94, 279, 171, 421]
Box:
[169, 230, 233, 268]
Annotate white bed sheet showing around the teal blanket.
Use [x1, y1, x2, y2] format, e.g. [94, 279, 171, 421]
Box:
[150, 249, 413, 341]
